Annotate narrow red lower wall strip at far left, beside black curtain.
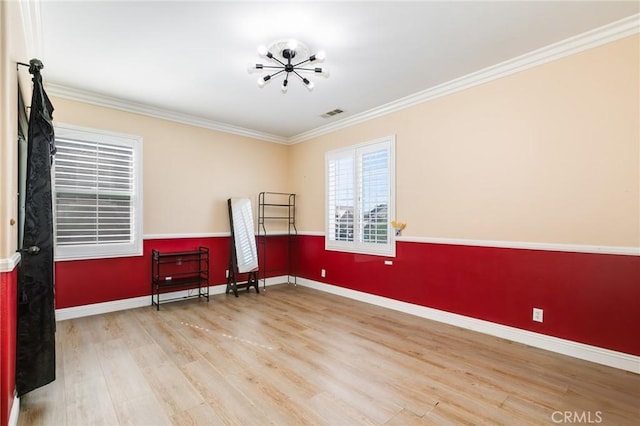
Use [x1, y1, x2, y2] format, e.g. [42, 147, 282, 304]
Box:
[0, 269, 18, 425]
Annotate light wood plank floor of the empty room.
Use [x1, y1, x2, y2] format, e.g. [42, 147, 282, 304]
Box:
[19, 285, 640, 426]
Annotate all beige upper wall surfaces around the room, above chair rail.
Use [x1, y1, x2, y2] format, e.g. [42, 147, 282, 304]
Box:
[6, 30, 640, 250]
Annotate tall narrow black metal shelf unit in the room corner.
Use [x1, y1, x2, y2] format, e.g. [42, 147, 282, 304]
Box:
[258, 192, 298, 289]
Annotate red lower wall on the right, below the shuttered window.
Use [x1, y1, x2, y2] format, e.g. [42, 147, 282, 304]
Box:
[299, 236, 640, 355]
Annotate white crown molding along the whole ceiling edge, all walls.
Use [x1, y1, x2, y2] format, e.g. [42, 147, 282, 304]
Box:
[37, 14, 640, 145]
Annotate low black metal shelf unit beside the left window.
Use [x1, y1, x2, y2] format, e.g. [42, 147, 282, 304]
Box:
[151, 247, 209, 310]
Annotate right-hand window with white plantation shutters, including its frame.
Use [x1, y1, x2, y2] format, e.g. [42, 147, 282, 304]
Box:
[325, 136, 395, 256]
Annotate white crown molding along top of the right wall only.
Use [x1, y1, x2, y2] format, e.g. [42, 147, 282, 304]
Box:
[288, 14, 640, 144]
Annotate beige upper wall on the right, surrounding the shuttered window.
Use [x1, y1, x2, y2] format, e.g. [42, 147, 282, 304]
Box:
[290, 36, 640, 247]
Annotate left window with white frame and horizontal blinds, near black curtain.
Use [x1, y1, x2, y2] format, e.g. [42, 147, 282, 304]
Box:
[53, 125, 142, 260]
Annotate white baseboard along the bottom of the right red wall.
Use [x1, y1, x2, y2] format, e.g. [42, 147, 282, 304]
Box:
[298, 277, 640, 374]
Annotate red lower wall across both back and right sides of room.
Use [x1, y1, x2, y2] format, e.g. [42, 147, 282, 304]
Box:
[56, 236, 640, 355]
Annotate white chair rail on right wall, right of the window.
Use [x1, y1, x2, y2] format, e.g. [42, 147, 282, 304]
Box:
[396, 236, 640, 256]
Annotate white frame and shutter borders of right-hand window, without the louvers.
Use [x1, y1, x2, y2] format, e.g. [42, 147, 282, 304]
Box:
[324, 135, 396, 257]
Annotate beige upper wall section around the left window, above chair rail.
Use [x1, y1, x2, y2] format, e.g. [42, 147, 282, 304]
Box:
[51, 97, 288, 235]
